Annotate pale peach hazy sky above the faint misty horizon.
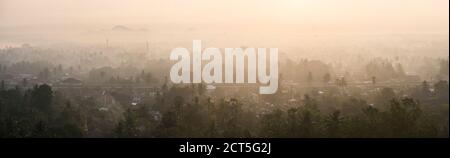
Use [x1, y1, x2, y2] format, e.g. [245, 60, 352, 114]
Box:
[0, 0, 449, 33]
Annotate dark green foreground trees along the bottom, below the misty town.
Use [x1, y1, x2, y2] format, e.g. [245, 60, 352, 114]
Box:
[0, 81, 448, 138]
